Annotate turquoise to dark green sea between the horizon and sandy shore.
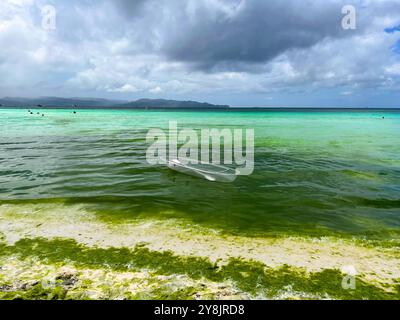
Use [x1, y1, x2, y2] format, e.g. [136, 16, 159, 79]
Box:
[0, 109, 400, 238]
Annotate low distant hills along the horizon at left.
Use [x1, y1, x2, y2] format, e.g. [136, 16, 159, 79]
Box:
[0, 97, 229, 109]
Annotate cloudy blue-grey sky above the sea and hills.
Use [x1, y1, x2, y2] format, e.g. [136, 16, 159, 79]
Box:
[0, 0, 400, 108]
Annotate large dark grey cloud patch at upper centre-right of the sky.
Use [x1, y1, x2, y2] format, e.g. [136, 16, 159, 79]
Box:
[170, 0, 342, 68]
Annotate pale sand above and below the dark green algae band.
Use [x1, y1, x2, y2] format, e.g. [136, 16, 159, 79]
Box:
[0, 203, 400, 299]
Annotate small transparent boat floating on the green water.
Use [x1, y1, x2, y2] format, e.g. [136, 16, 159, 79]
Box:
[167, 158, 239, 182]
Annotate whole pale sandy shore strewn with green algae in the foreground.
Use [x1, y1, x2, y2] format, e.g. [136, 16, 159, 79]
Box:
[0, 203, 400, 299]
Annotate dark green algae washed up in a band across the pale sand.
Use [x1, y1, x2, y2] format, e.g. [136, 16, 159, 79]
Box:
[0, 238, 400, 299]
